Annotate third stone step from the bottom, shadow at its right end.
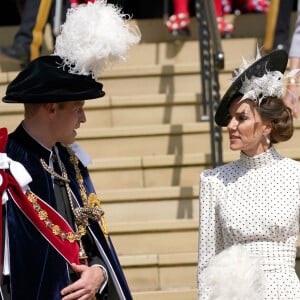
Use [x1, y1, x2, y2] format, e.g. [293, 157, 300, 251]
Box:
[98, 185, 199, 224]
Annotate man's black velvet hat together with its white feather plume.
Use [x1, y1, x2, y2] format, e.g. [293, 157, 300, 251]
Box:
[3, 0, 141, 103]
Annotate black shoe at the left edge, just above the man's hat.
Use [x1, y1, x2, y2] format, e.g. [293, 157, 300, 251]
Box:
[0, 44, 29, 67]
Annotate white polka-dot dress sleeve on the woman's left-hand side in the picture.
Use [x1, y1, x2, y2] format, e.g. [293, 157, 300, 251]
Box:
[198, 170, 224, 300]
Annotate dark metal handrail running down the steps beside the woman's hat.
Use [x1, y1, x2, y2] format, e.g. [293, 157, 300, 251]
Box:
[195, 0, 224, 167]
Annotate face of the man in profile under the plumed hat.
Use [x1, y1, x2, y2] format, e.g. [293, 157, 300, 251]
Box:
[53, 101, 86, 145]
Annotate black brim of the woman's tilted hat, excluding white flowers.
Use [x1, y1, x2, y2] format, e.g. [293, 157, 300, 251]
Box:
[215, 50, 288, 126]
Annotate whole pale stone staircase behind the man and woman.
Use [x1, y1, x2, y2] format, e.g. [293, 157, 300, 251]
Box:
[0, 15, 300, 300]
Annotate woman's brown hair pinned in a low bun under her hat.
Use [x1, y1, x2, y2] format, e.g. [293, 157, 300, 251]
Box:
[257, 97, 294, 144]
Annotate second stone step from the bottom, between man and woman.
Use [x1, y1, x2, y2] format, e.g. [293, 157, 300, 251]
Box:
[108, 219, 199, 256]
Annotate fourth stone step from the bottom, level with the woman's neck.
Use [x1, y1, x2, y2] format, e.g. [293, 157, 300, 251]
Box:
[89, 144, 300, 190]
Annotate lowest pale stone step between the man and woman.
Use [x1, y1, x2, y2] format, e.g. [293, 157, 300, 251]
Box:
[120, 253, 197, 292]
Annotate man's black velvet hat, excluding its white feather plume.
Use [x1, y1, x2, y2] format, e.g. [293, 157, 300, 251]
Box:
[2, 55, 105, 103]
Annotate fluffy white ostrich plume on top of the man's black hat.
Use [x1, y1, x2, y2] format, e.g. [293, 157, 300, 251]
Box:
[54, 0, 141, 78]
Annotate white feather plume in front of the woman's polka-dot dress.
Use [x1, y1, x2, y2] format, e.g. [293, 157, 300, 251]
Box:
[200, 245, 265, 300]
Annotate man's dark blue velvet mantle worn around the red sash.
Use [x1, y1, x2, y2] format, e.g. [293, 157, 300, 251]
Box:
[6, 124, 132, 300]
